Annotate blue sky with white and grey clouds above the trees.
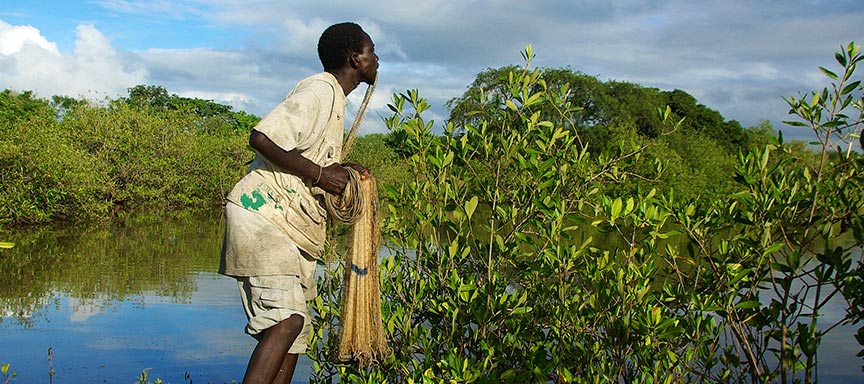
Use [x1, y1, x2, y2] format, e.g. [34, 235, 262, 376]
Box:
[0, 0, 864, 139]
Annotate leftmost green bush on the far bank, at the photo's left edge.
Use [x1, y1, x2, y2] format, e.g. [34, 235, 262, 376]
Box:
[0, 92, 110, 224]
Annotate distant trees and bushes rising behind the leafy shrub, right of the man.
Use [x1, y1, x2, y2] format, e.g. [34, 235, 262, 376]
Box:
[446, 59, 751, 199]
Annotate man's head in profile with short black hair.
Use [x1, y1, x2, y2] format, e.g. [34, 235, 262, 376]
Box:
[318, 22, 378, 84]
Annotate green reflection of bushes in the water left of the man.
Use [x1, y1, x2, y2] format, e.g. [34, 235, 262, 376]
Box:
[0, 208, 221, 324]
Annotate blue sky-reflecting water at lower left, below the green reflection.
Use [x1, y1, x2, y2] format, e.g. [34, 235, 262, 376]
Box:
[0, 272, 254, 383]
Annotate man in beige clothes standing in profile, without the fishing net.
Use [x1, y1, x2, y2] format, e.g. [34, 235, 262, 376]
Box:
[219, 23, 378, 384]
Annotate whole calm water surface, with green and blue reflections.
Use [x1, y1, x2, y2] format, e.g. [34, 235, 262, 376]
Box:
[0, 211, 864, 383]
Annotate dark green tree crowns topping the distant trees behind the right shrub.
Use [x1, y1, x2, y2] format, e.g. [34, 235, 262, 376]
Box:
[448, 62, 748, 155]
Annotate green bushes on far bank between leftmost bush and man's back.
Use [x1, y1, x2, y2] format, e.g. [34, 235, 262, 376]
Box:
[63, 100, 248, 206]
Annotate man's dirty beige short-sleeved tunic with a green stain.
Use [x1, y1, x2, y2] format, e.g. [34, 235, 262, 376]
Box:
[219, 72, 347, 287]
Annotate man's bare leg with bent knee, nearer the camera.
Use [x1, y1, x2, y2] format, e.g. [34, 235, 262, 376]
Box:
[243, 315, 304, 384]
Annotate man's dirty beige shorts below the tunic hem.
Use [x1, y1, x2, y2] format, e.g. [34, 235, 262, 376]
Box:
[237, 276, 312, 354]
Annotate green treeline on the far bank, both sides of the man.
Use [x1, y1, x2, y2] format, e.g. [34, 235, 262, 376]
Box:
[0, 67, 809, 225]
